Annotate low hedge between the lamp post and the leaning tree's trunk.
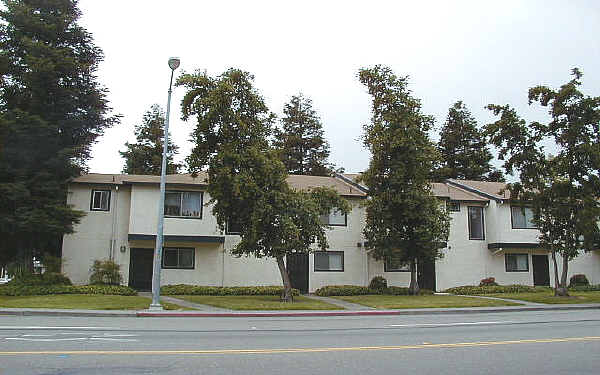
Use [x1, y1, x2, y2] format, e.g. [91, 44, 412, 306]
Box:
[160, 284, 300, 296]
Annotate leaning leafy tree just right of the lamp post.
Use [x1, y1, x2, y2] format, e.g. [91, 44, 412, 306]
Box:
[177, 69, 349, 301]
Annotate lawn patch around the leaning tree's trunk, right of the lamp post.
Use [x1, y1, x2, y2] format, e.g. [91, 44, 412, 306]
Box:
[174, 296, 343, 310]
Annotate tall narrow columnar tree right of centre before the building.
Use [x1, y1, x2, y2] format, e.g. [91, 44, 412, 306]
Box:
[358, 65, 450, 294]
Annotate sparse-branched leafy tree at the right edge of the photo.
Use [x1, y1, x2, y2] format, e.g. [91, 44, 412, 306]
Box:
[486, 68, 600, 296]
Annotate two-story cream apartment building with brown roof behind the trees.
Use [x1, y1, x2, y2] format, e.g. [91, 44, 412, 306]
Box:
[63, 174, 600, 292]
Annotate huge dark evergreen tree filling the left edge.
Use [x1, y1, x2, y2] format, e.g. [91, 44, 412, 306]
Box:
[0, 0, 118, 264]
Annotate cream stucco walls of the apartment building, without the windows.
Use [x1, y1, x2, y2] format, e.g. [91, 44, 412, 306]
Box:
[63, 175, 600, 292]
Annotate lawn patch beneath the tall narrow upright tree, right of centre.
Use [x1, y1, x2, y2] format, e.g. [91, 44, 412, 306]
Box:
[333, 295, 520, 309]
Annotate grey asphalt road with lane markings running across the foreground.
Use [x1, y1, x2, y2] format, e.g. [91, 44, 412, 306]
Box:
[0, 310, 600, 375]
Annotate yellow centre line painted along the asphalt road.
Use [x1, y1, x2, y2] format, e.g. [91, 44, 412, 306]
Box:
[0, 336, 600, 355]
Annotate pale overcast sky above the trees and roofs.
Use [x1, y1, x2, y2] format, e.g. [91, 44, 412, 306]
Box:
[79, 0, 600, 173]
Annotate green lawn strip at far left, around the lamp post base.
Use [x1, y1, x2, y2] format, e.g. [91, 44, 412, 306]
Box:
[0, 294, 182, 310]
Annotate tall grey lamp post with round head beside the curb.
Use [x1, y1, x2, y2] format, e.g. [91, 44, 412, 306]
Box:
[150, 57, 180, 310]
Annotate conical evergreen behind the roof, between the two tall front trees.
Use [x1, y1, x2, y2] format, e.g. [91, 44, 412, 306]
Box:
[274, 94, 331, 176]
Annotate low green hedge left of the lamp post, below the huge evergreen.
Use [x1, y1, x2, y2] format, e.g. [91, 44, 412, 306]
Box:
[0, 284, 137, 296]
